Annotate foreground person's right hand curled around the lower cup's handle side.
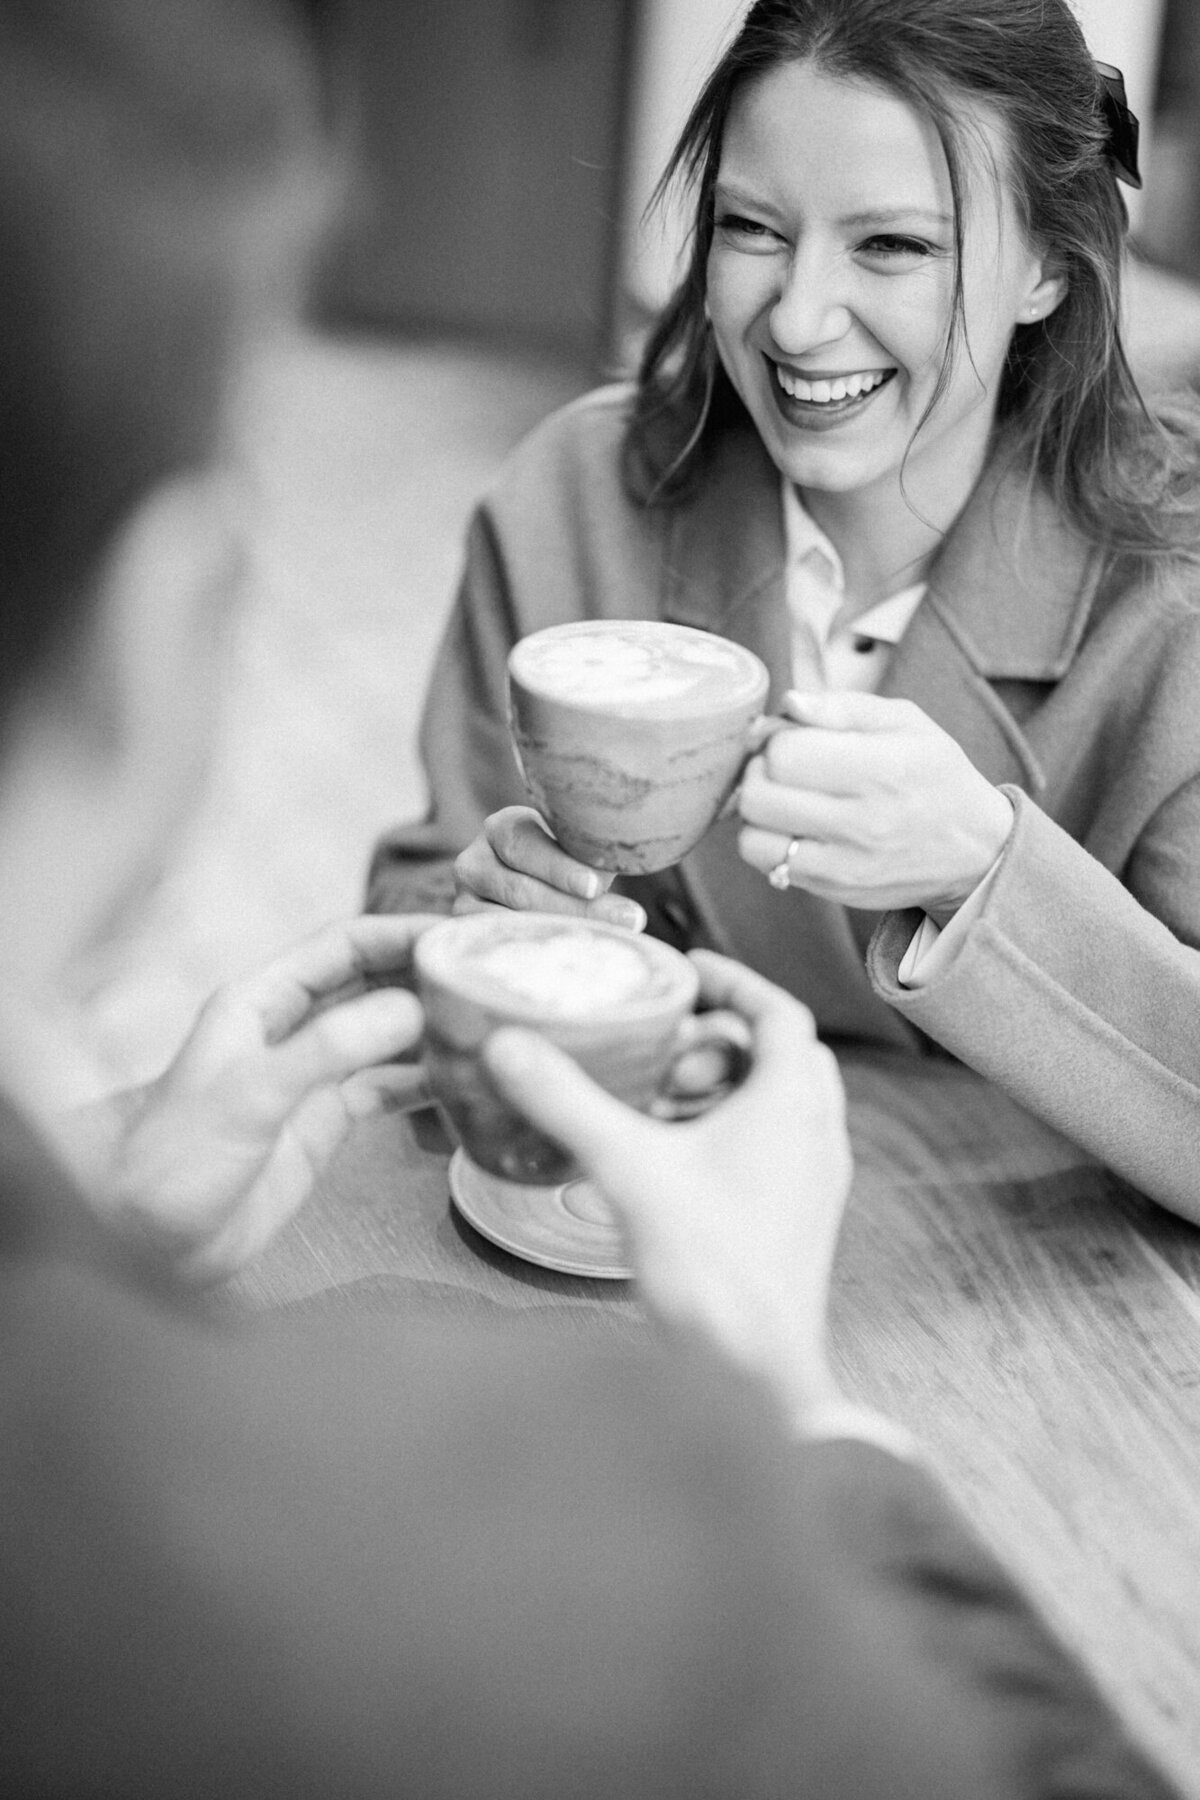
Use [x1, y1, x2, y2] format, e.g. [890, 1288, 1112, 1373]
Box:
[488, 952, 851, 1429]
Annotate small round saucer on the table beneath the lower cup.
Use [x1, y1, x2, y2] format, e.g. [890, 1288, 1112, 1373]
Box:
[450, 1150, 633, 1282]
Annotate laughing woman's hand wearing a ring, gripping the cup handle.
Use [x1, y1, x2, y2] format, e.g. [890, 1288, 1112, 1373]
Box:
[738, 693, 1013, 923]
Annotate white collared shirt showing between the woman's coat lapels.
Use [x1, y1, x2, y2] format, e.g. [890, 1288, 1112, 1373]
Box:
[783, 481, 925, 693]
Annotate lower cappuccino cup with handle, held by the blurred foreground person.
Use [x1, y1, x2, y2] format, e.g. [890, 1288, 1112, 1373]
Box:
[414, 913, 750, 1186]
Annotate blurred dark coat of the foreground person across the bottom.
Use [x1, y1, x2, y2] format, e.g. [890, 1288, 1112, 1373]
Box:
[0, 1273, 1168, 1800]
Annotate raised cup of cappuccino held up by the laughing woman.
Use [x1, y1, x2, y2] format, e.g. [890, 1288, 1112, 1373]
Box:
[509, 619, 768, 875]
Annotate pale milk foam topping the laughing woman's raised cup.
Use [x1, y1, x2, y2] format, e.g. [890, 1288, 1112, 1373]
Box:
[513, 625, 756, 706]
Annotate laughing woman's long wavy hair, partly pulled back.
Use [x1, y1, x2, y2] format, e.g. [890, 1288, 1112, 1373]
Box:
[624, 0, 1200, 554]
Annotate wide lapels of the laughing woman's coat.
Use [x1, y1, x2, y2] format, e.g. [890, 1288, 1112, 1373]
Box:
[660, 428, 1105, 796]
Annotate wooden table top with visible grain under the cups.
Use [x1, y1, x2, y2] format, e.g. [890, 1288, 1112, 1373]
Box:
[237, 1055, 1200, 1800]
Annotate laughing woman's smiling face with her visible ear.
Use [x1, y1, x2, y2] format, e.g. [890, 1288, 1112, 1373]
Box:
[707, 63, 1063, 524]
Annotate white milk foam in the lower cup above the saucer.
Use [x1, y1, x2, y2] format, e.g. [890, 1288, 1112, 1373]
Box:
[471, 931, 653, 1017]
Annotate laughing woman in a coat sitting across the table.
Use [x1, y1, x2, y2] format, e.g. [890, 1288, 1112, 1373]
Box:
[371, 0, 1200, 1219]
